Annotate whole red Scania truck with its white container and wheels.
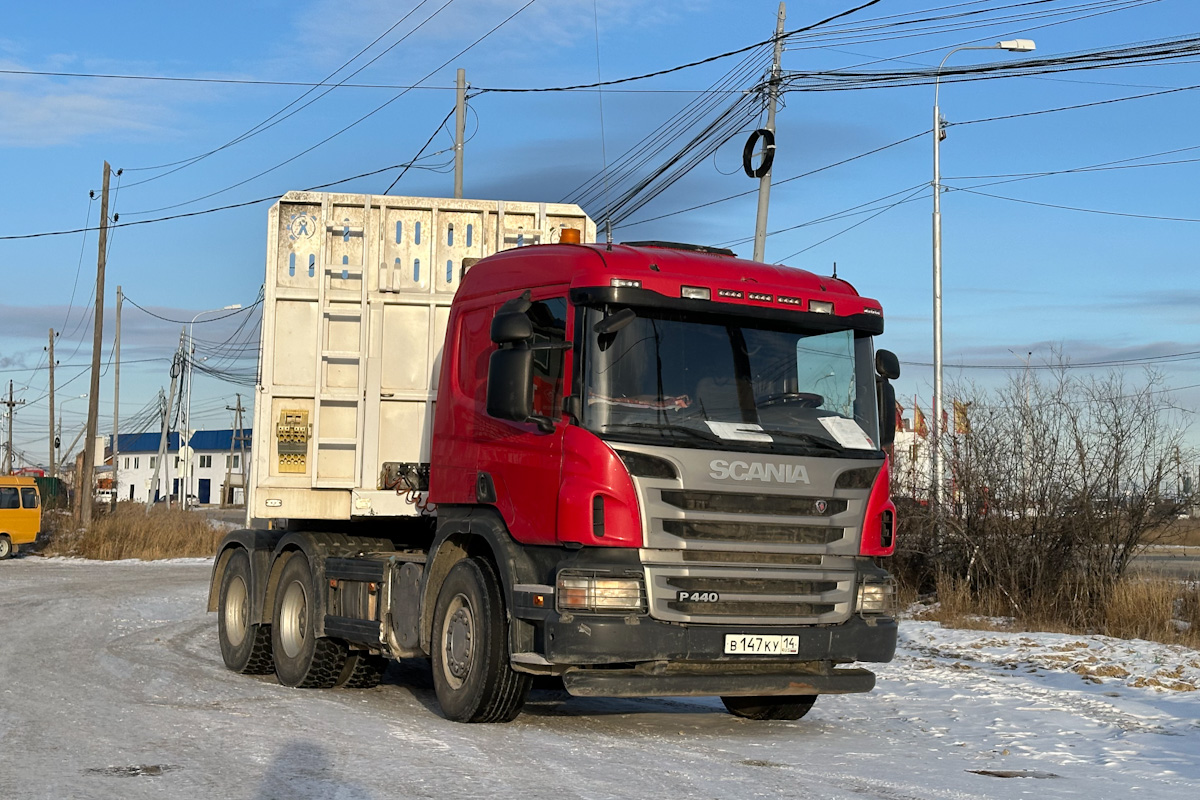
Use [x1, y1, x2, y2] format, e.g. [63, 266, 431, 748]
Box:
[209, 192, 899, 722]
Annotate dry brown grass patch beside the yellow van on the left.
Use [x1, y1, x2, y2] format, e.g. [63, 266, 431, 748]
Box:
[41, 503, 223, 561]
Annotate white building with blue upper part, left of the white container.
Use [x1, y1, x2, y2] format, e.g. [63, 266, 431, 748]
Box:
[116, 428, 251, 505]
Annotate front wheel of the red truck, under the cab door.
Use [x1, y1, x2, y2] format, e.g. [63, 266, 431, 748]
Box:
[431, 559, 532, 722]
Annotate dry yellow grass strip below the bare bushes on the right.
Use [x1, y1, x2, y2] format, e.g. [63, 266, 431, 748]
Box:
[918, 576, 1200, 649]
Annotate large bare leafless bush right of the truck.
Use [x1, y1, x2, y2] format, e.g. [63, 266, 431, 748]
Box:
[896, 365, 1190, 628]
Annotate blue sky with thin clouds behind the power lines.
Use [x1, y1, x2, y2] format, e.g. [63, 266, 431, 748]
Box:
[0, 0, 1200, 462]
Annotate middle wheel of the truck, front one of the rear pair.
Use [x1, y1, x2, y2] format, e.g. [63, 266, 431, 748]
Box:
[271, 553, 347, 688]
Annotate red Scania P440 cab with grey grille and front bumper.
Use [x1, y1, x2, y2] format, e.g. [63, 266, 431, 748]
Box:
[430, 243, 895, 697]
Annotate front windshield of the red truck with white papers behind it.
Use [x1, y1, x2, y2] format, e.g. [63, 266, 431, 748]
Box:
[583, 307, 880, 457]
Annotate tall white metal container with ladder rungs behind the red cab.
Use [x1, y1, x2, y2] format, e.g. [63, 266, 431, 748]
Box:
[247, 192, 595, 519]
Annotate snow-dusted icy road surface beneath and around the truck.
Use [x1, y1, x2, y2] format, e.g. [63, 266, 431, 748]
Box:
[0, 558, 1200, 800]
